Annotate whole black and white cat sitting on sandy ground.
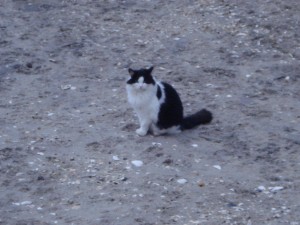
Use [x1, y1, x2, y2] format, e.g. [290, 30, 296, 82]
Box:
[126, 67, 212, 136]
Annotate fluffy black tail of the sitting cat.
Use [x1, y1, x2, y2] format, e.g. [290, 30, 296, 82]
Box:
[181, 109, 213, 130]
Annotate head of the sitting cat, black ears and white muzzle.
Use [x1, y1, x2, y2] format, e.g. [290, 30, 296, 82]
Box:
[127, 67, 155, 91]
